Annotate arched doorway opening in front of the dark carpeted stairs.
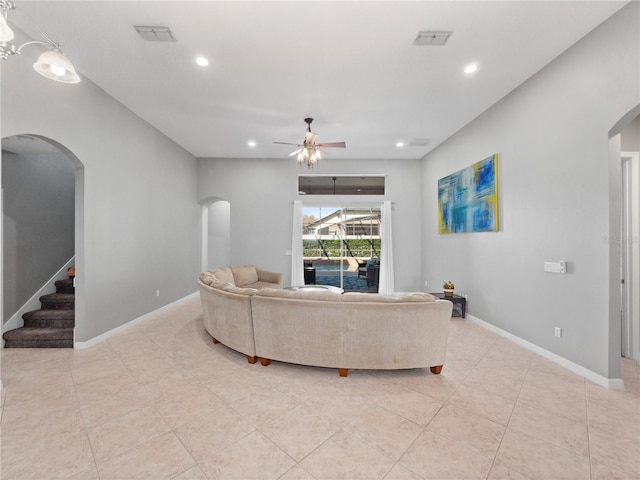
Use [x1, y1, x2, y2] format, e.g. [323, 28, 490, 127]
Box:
[0, 133, 84, 346]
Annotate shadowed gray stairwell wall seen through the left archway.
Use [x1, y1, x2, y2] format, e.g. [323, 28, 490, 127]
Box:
[2, 147, 75, 322]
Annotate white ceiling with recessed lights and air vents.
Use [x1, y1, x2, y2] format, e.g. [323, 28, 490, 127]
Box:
[7, 0, 627, 159]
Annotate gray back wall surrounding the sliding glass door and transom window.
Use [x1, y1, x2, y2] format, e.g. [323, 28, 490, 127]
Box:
[198, 157, 424, 291]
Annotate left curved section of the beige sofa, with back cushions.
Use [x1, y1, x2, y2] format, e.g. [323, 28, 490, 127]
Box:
[198, 265, 282, 363]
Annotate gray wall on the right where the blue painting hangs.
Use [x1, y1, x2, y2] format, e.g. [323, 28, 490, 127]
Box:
[422, 2, 640, 378]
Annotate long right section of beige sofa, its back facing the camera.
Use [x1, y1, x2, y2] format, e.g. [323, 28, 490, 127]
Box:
[251, 289, 453, 377]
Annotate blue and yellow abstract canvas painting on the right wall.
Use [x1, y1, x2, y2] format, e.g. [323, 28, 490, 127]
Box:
[438, 155, 498, 233]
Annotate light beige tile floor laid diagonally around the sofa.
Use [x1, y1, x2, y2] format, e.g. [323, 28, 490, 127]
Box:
[0, 297, 640, 480]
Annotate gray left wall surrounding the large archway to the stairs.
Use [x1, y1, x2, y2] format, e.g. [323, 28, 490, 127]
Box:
[1, 44, 200, 342]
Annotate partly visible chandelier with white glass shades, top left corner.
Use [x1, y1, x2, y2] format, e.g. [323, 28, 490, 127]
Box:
[0, 0, 80, 83]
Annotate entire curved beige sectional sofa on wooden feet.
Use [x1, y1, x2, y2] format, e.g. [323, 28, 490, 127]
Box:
[198, 267, 453, 376]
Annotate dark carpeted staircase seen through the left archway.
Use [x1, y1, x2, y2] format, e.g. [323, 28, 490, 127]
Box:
[2, 278, 75, 348]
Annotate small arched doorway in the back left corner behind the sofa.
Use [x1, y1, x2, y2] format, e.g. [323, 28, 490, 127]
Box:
[200, 197, 231, 272]
